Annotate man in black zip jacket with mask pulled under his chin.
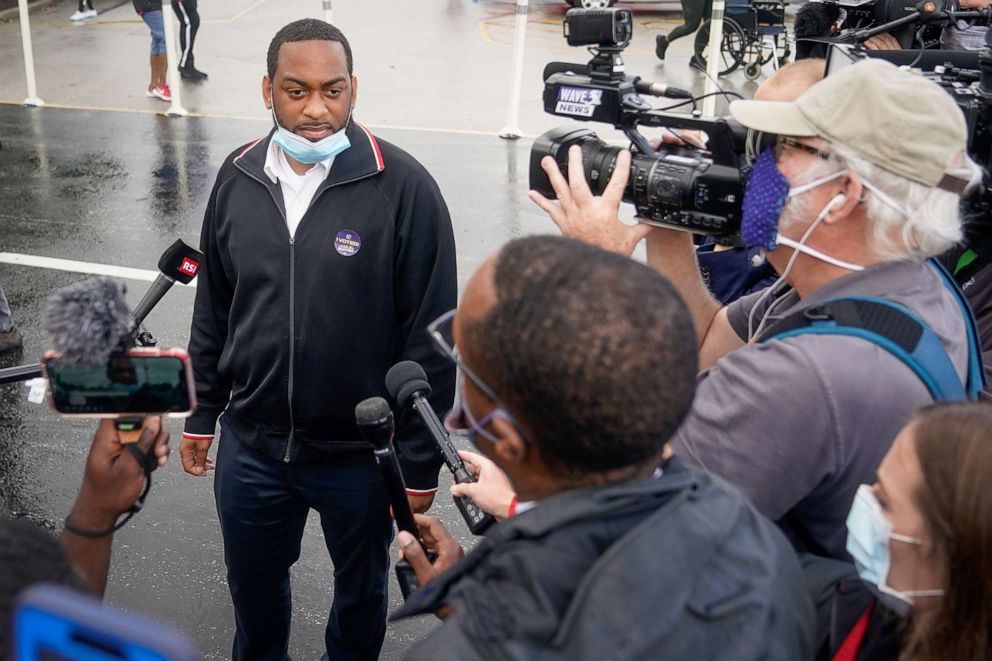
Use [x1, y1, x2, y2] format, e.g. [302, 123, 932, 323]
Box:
[180, 19, 456, 661]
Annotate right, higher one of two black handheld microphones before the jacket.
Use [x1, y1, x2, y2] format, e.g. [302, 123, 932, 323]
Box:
[386, 360, 496, 535]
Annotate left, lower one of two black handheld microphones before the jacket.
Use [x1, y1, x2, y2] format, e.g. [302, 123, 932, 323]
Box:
[355, 397, 433, 601]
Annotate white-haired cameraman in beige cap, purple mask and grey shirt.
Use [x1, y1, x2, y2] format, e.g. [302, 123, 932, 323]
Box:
[532, 60, 979, 559]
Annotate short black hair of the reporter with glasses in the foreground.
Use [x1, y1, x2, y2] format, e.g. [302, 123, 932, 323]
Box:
[465, 236, 698, 476]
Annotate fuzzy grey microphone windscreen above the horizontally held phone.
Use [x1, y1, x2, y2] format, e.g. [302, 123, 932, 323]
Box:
[45, 278, 131, 365]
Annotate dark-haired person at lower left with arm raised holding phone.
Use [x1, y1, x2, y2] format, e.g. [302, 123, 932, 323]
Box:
[0, 417, 169, 658]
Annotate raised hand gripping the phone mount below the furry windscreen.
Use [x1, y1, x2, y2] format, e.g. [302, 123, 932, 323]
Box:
[70, 417, 169, 530]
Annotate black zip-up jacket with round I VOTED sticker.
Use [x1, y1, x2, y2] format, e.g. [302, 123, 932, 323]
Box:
[186, 123, 457, 491]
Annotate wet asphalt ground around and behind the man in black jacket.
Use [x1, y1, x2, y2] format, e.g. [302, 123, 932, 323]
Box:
[0, 0, 780, 659]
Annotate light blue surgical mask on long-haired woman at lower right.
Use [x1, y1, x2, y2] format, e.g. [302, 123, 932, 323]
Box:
[847, 484, 944, 616]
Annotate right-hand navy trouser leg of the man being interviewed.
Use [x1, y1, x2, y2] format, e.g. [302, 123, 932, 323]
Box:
[293, 463, 393, 661]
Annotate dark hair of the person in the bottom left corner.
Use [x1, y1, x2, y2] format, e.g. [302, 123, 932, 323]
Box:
[0, 517, 91, 659]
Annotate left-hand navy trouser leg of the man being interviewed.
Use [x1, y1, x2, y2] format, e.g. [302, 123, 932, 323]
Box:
[214, 419, 310, 661]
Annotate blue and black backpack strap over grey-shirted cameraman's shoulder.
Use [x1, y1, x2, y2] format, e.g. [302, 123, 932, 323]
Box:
[759, 297, 964, 402]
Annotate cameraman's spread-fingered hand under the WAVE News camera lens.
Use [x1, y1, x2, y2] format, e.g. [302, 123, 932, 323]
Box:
[529, 145, 651, 256]
